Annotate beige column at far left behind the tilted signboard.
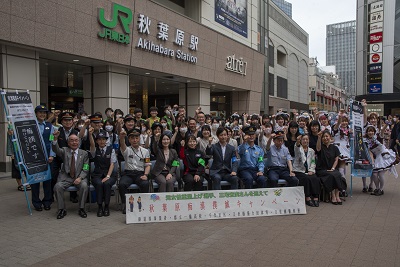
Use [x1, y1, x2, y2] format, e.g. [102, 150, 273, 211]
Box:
[0, 45, 40, 172]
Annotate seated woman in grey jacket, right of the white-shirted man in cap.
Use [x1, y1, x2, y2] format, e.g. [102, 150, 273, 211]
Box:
[151, 133, 179, 192]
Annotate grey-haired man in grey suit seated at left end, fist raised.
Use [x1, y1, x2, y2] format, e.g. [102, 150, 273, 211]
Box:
[52, 131, 89, 219]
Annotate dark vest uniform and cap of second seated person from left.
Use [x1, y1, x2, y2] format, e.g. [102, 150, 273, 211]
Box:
[90, 130, 117, 217]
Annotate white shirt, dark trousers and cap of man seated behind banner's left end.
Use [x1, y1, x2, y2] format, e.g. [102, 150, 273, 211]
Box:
[119, 129, 151, 207]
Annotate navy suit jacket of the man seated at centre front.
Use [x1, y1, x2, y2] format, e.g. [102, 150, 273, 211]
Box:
[206, 142, 238, 176]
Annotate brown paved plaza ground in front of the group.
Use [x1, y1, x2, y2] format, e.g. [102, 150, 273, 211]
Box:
[0, 167, 400, 266]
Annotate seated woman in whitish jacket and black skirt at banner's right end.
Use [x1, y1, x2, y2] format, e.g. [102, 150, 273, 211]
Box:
[293, 135, 321, 207]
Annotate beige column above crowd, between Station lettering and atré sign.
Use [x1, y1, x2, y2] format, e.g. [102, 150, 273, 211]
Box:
[187, 83, 211, 116]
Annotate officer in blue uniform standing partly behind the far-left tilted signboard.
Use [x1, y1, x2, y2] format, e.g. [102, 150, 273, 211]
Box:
[31, 105, 56, 211]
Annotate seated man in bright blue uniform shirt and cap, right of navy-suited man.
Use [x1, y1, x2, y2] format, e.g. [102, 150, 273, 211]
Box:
[238, 125, 267, 189]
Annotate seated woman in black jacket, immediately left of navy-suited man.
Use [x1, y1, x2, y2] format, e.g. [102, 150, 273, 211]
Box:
[179, 134, 205, 191]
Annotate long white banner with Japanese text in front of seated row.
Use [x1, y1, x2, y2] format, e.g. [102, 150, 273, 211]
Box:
[126, 186, 306, 224]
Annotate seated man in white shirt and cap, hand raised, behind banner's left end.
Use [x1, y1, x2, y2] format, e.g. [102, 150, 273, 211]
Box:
[119, 128, 151, 214]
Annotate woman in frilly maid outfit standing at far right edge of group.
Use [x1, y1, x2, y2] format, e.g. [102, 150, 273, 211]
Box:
[365, 125, 398, 196]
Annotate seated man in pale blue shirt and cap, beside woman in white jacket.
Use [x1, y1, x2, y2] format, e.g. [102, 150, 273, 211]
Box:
[265, 131, 299, 187]
